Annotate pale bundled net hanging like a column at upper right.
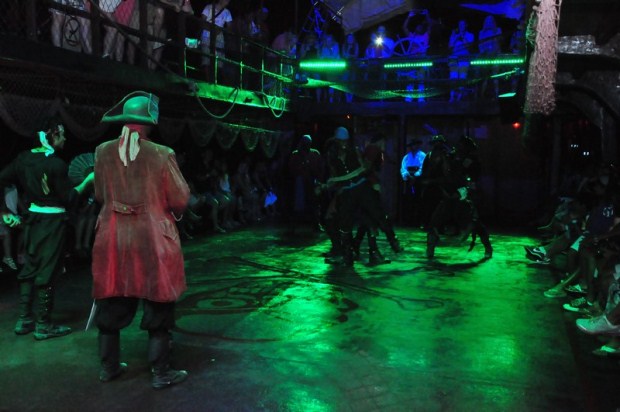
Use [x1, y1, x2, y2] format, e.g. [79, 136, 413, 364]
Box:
[524, 0, 562, 115]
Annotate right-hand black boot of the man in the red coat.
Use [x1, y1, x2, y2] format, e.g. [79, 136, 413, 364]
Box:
[149, 331, 188, 389]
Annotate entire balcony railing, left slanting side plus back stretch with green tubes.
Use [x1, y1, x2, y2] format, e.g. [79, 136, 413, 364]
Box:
[0, 0, 524, 102]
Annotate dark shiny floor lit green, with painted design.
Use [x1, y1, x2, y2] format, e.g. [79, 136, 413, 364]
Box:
[0, 225, 620, 411]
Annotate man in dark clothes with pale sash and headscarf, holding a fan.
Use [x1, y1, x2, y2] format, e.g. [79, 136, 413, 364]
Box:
[0, 120, 93, 340]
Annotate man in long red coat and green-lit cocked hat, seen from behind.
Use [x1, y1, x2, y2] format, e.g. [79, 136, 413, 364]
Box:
[92, 92, 189, 389]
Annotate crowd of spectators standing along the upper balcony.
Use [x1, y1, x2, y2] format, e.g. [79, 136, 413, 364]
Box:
[1, 0, 525, 102]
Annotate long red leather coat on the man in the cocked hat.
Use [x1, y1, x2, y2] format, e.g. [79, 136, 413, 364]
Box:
[92, 139, 189, 302]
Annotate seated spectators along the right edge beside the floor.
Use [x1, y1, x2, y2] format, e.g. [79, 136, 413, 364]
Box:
[525, 163, 620, 356]
